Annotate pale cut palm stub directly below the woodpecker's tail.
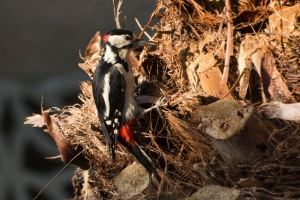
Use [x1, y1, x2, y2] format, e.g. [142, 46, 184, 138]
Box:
[114, 162, 149, 199]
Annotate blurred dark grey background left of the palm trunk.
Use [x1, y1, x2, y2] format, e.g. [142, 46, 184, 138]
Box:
[0, 0, 155, 200]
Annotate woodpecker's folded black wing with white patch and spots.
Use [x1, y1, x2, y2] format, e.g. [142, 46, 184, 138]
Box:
[93, 61, 126, 161]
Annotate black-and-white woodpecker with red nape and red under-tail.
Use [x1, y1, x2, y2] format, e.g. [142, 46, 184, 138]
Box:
[93, 29, 161, 183]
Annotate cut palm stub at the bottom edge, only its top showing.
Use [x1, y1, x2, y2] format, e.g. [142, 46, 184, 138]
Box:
[186, 185, 241, 200]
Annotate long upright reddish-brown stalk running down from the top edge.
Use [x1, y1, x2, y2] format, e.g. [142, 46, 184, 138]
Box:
[219, 0, 233, 94]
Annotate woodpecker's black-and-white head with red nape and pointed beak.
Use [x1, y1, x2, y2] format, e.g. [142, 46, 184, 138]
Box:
[102, 29, 156, 63]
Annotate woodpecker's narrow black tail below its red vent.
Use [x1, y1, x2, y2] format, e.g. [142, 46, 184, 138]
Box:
[126, 144, 161, 184]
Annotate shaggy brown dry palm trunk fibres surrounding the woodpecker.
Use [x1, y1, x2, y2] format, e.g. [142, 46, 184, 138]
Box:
[27, 0, 300, 199]
